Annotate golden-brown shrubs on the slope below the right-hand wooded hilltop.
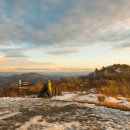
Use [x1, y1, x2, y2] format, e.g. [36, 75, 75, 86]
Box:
[88, 69, 130, 97]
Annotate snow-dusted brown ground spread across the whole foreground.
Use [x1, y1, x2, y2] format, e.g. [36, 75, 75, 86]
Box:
[0, 92, 130, 130]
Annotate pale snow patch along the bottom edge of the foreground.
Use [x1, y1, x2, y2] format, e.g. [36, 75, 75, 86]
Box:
[17, 116, 81, 130]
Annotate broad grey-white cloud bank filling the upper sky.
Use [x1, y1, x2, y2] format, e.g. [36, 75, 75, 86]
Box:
[0, 0, 130, 55]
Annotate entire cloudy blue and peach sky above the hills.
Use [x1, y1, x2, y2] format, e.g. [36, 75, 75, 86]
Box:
[0, 0, 130, 72]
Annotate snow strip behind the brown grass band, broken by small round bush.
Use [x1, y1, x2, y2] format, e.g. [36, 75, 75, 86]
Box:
[53, 92, 130, 108]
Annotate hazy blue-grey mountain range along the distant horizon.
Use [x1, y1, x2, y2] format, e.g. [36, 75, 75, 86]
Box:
[0, 72, 88, 87]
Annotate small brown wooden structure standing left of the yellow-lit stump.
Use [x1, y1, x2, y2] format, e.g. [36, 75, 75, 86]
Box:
[18, 80, 29, 97]
